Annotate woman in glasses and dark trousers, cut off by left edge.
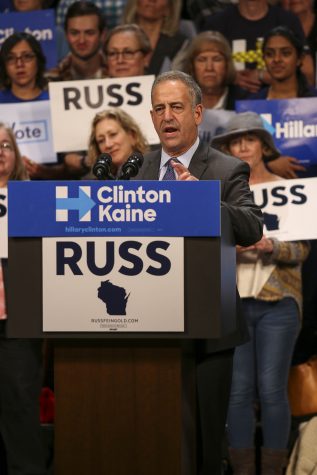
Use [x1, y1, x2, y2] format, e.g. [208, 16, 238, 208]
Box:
[0, 123, 46, 475]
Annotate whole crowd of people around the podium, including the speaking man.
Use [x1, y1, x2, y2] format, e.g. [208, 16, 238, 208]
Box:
[0, 0, 317, 475]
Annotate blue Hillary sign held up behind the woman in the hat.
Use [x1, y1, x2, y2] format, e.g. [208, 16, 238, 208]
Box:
[236, 97, 317, 167]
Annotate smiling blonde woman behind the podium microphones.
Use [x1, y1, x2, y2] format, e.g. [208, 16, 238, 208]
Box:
[88, 108, 149, 176]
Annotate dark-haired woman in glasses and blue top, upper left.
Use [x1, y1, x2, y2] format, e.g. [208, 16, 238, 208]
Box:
[0, 33, 48, 103]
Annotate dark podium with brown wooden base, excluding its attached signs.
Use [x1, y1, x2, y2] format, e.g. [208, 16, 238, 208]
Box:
[8, 182, 235, 475]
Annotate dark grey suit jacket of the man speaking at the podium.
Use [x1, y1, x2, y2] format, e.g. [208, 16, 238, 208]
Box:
[135, 142, 263, 353]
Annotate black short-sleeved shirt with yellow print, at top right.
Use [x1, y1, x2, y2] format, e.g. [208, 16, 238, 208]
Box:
[202, 5, 306, 70]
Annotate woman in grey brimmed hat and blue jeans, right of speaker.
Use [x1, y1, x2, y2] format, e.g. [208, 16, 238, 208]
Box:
[212, 112, 309, 475]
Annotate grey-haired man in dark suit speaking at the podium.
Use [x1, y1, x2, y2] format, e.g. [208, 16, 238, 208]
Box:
[136, 71, 262, 475]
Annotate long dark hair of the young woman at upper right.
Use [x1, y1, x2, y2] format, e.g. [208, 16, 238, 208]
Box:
[262, 26, 312, 97]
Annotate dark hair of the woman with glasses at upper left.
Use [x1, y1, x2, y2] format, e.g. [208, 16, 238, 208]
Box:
[0, 32, 47, 89]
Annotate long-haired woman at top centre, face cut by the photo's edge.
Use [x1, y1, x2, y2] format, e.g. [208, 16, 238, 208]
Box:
[122, 0, 189, 75]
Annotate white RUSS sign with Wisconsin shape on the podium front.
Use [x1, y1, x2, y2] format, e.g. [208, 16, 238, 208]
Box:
[43, 236, 184, 332]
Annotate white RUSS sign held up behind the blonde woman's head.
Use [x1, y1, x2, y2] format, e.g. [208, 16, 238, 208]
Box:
[49, 76, 159, 152]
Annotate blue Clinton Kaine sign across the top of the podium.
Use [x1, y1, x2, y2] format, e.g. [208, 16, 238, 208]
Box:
[9, 181, 220, 237]
